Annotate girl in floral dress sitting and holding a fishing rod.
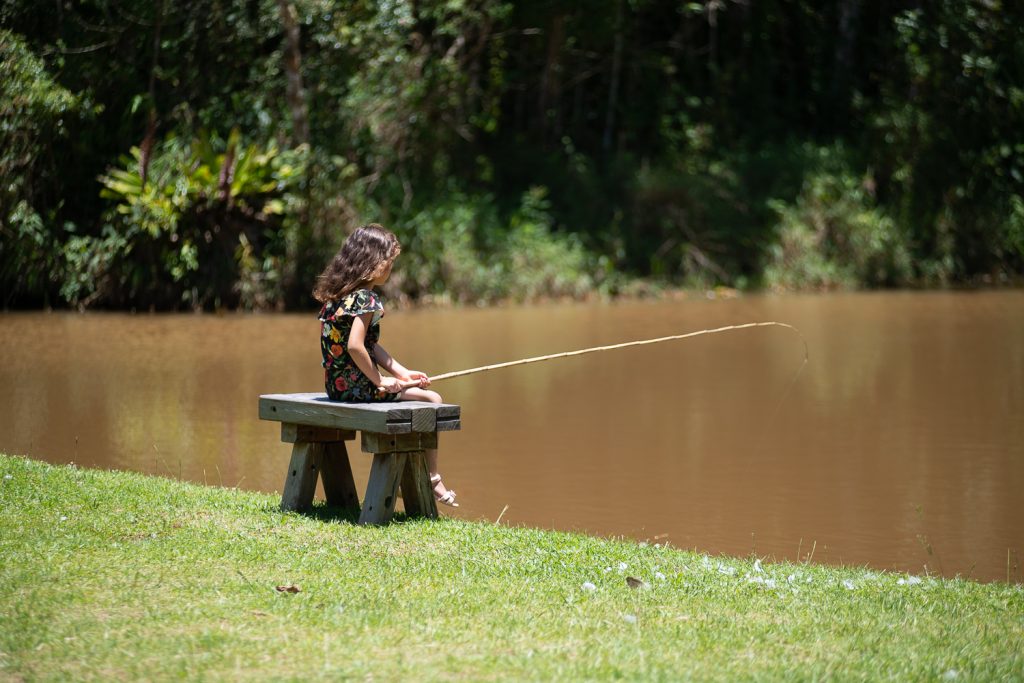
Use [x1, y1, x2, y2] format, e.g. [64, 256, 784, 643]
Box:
[313, 223, 459, 508]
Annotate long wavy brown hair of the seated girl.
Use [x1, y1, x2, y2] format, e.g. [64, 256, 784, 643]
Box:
[313, 223, 401, 303]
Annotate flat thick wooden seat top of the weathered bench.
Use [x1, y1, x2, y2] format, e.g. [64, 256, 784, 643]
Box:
[259, 393, 461, 434]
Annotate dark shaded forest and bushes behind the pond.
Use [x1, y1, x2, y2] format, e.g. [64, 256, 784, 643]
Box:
[0, 0, 1024, 309]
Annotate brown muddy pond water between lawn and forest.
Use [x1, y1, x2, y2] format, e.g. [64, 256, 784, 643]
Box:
[0, 291, 1024, 582]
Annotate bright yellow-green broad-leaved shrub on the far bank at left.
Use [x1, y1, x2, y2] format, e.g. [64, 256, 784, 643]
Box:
[61, 130, 305, 308]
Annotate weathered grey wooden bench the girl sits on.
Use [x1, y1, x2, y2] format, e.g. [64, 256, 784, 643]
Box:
[259, 393, 461, 524]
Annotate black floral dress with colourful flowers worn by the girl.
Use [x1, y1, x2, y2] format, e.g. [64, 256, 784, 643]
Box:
[319, 290, 398, 403]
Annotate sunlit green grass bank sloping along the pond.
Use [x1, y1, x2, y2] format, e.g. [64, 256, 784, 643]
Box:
[0, 456, 1024, 681]
